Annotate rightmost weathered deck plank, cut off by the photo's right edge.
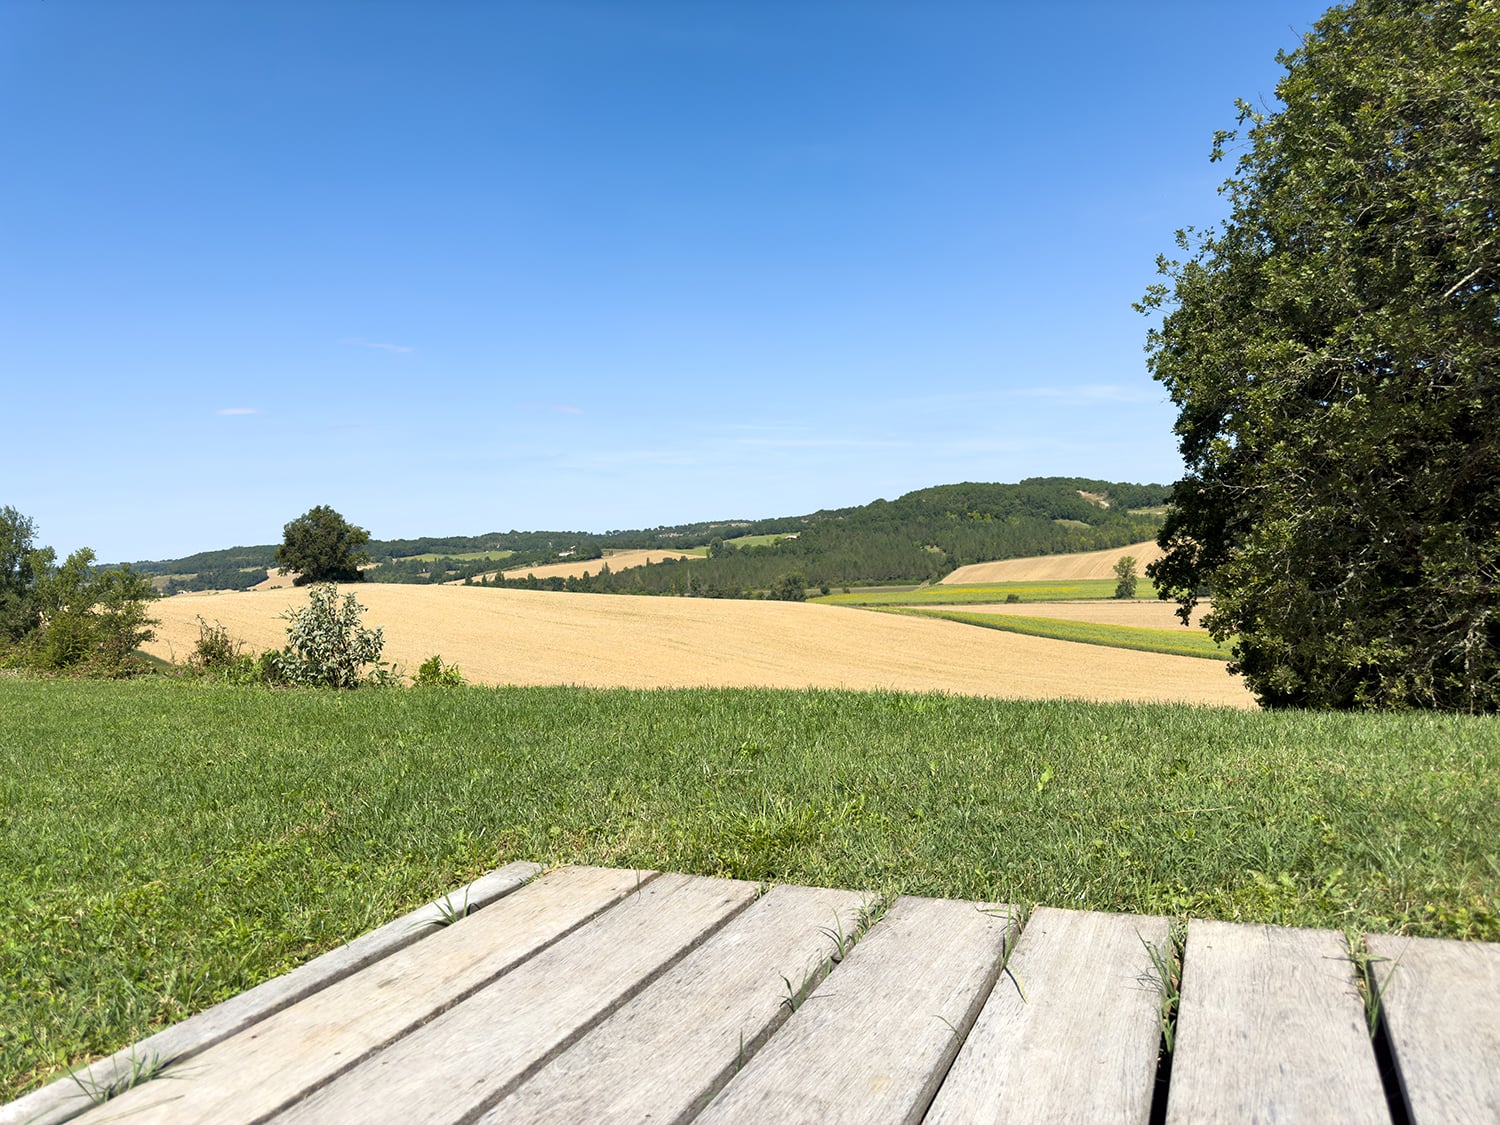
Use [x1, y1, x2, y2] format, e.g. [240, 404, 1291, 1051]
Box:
[1365, 935, 1500, 1125]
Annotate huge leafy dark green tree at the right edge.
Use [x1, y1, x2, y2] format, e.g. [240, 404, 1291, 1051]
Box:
[1143, 0, 1500, 711]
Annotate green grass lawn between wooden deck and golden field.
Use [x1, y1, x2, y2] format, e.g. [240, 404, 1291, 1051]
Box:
[0, 678, 1500, 1100]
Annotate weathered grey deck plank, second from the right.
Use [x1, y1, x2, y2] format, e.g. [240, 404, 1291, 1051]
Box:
[1167, 920, 1391, 1125]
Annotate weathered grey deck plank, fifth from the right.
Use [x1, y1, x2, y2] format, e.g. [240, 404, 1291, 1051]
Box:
[480, 887, 864, 1125]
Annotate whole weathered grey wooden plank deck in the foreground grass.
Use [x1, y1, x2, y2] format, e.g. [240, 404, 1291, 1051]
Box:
[11, 864, 1500, 1125]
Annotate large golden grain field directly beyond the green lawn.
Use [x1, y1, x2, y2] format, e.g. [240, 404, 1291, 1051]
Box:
[147, 584, 1254, 708]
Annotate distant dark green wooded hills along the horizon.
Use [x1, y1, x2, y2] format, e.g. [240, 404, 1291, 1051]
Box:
[135, 477, 1170, 597]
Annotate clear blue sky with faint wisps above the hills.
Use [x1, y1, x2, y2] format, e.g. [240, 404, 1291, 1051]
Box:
[0, 0, 1326, 561]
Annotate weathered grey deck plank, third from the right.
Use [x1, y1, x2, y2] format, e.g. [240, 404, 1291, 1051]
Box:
[926, 906, 1172, 1125]
